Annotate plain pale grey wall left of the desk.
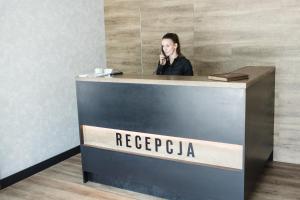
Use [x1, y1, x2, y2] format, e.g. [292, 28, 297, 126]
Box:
[0, 0, 106, 178]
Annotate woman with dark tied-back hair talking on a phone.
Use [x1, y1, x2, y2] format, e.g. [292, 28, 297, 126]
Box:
[156, 33, 193, 76]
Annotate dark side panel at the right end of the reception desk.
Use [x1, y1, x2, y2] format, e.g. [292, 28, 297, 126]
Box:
[245, 72, 275, 199]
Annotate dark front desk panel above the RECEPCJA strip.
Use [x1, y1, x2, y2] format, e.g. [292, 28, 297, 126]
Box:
[76, 81, 245, 145]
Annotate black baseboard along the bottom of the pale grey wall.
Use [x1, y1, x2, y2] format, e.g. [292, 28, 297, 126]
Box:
[0, 146, 80, 190]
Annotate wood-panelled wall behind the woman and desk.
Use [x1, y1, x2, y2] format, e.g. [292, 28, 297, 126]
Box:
[104, 0, 300, 164]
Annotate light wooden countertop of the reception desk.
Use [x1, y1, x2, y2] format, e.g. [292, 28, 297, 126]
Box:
[76, 66, 275, 88]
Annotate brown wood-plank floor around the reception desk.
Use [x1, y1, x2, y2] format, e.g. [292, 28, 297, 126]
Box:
[0, 154, 300, 200]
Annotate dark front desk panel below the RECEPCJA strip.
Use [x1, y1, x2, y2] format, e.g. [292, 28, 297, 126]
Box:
[81, 146, 244, 200]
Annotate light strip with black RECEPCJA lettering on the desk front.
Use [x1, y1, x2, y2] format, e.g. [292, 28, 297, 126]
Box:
[82, 125, 243, 170]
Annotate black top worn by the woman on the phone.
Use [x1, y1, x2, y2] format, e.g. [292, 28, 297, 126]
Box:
[156, 56, 193, 76]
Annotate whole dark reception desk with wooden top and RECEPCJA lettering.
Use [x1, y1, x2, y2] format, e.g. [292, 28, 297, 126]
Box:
[76, 67, 275, 200]
